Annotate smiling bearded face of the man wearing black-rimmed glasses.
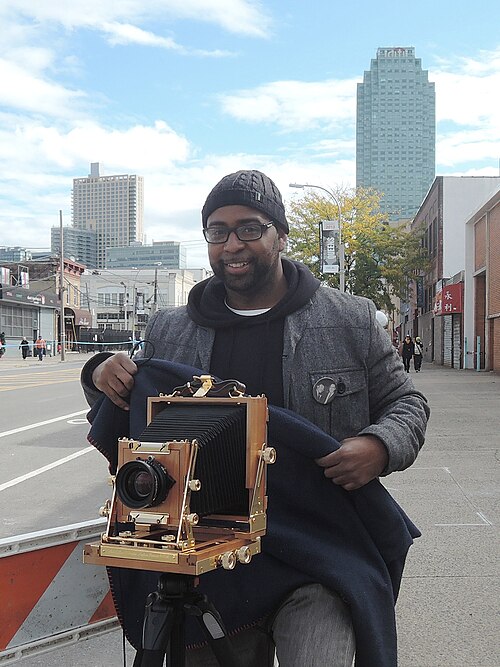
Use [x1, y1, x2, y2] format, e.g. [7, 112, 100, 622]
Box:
[207, 206, 286, 295]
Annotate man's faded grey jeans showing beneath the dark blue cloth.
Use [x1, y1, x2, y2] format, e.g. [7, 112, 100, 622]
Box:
[186, 584, 355, 667]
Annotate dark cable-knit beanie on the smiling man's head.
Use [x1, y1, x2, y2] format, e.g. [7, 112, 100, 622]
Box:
[201, 169, 289, 234]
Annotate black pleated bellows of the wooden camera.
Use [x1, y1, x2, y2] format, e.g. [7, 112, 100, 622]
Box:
[140, 403, 248, 517]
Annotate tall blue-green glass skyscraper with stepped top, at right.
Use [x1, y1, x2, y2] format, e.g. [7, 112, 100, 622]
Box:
[356, 47, 436, 220]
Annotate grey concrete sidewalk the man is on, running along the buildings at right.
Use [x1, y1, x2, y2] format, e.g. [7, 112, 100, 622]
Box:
[7, 362, 500, 667]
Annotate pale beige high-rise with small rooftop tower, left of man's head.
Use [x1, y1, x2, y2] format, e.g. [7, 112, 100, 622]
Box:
[72, 162, 144, 268]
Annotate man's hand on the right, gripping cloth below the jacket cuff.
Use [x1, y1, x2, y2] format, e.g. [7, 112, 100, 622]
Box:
[316, 435, 389, 491]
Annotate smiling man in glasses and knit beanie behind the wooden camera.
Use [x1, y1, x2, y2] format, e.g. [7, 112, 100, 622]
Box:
[82, 171, 428, 667]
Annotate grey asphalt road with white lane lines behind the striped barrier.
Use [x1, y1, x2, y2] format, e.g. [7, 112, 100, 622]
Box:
[0, 355, 109, 537]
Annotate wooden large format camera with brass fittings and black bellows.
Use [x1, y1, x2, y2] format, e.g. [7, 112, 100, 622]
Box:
[84, 376, 276, 576]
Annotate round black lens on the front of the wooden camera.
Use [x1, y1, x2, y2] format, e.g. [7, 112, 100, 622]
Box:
[116, 456, 175, 509]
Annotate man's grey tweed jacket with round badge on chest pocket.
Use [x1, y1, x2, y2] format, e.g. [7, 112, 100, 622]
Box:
[84, 286, 430, 474]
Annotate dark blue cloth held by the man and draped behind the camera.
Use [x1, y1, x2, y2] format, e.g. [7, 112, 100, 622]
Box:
[89, 359, 420, 667]
